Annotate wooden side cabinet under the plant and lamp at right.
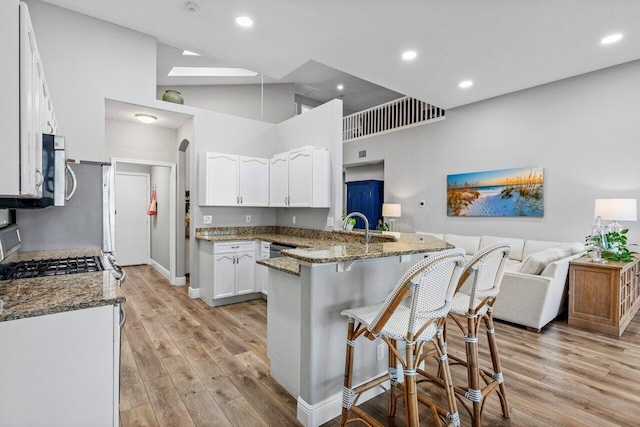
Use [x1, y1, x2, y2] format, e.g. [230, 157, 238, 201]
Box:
[569, 256, 640, 337]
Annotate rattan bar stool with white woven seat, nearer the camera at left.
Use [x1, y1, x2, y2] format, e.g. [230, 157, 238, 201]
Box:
[340, 249, 464, 426]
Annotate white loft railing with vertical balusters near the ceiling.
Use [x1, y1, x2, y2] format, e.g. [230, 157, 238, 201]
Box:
[342, 96, 445, 142]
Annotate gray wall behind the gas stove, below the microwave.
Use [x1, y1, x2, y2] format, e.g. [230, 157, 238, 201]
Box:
[16, 164, 102, 251]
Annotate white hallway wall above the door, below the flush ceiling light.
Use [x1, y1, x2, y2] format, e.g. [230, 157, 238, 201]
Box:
[104, 119, 178, 163]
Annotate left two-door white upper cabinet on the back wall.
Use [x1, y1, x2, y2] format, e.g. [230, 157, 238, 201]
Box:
[200, 153, 269, 206]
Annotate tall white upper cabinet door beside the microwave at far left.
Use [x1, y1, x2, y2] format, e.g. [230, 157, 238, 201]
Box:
[20, 4, 42, 197]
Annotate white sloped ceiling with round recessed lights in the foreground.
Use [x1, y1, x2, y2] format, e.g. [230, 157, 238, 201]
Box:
[45, 0, 640, 108]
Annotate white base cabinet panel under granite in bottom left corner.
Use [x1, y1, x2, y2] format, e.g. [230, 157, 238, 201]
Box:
[0, 305, 120, 427]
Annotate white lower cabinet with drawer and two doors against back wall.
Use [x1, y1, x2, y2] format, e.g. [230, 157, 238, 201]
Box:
[200, 241, 260, 306]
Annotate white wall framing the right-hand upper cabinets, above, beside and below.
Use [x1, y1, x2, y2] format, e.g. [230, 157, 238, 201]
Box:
[276, 99, 342, 230]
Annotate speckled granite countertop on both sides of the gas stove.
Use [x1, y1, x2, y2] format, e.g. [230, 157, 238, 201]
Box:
[0, 249, 125, 322]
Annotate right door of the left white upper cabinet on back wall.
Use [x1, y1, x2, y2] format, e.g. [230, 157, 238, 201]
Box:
[239, 157, 269, 206]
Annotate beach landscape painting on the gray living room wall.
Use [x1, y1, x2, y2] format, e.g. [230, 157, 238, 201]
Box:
[447, 167, 544, 217]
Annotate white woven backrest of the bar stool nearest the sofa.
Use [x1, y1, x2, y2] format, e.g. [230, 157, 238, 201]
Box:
[458, 242, 511, 309]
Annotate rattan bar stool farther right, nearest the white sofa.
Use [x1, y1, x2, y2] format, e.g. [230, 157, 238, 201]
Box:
[445, 242, 510, 427]
